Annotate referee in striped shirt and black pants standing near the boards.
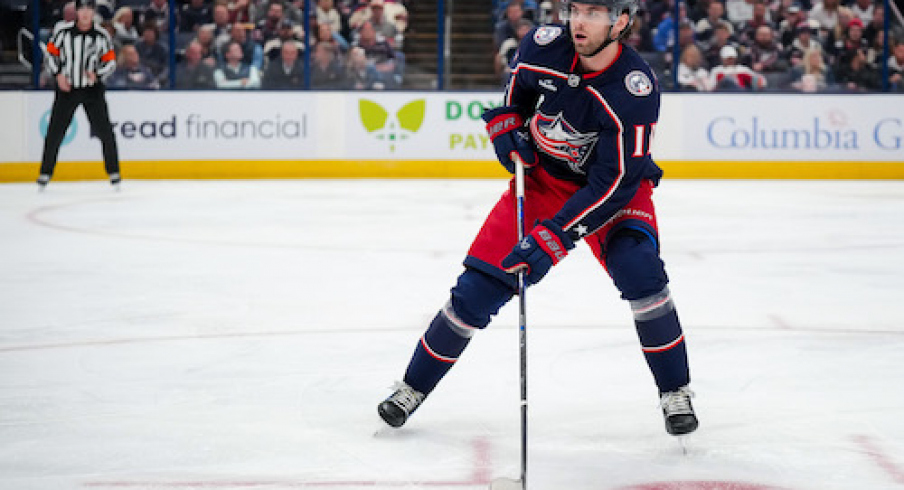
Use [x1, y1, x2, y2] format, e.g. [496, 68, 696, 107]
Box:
[38, 0, 121, 190]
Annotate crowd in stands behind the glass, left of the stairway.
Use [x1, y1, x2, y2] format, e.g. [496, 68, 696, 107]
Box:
[34, 0, 408, 90]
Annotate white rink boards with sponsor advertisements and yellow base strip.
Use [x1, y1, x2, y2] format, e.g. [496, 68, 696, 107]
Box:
[0, 91, 904, 182]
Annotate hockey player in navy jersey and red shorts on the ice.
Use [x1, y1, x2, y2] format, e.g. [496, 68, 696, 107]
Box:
[377, 0, 697, 435]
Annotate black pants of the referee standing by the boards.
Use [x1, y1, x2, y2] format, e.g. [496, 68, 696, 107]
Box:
[41, 83, 119, 176]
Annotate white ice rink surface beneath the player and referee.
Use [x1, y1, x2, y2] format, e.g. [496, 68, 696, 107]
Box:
[0, 180, 904, 490]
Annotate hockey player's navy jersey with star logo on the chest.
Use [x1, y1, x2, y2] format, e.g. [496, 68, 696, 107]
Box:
[505, 26, 662, 243]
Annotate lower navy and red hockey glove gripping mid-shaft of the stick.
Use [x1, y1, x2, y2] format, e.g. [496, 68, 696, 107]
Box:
[502, 220, 574, 285]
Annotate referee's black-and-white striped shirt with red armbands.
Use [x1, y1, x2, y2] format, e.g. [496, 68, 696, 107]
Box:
[47, 21, 116, 88]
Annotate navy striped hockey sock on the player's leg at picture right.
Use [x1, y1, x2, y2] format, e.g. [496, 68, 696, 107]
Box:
[630, 288, 690, 393]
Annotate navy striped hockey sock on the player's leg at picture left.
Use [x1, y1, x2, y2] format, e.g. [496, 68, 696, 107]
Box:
[405, 303, 476, 395]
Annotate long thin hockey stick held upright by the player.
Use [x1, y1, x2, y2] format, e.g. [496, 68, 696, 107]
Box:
[490, 152, 527, 490]
